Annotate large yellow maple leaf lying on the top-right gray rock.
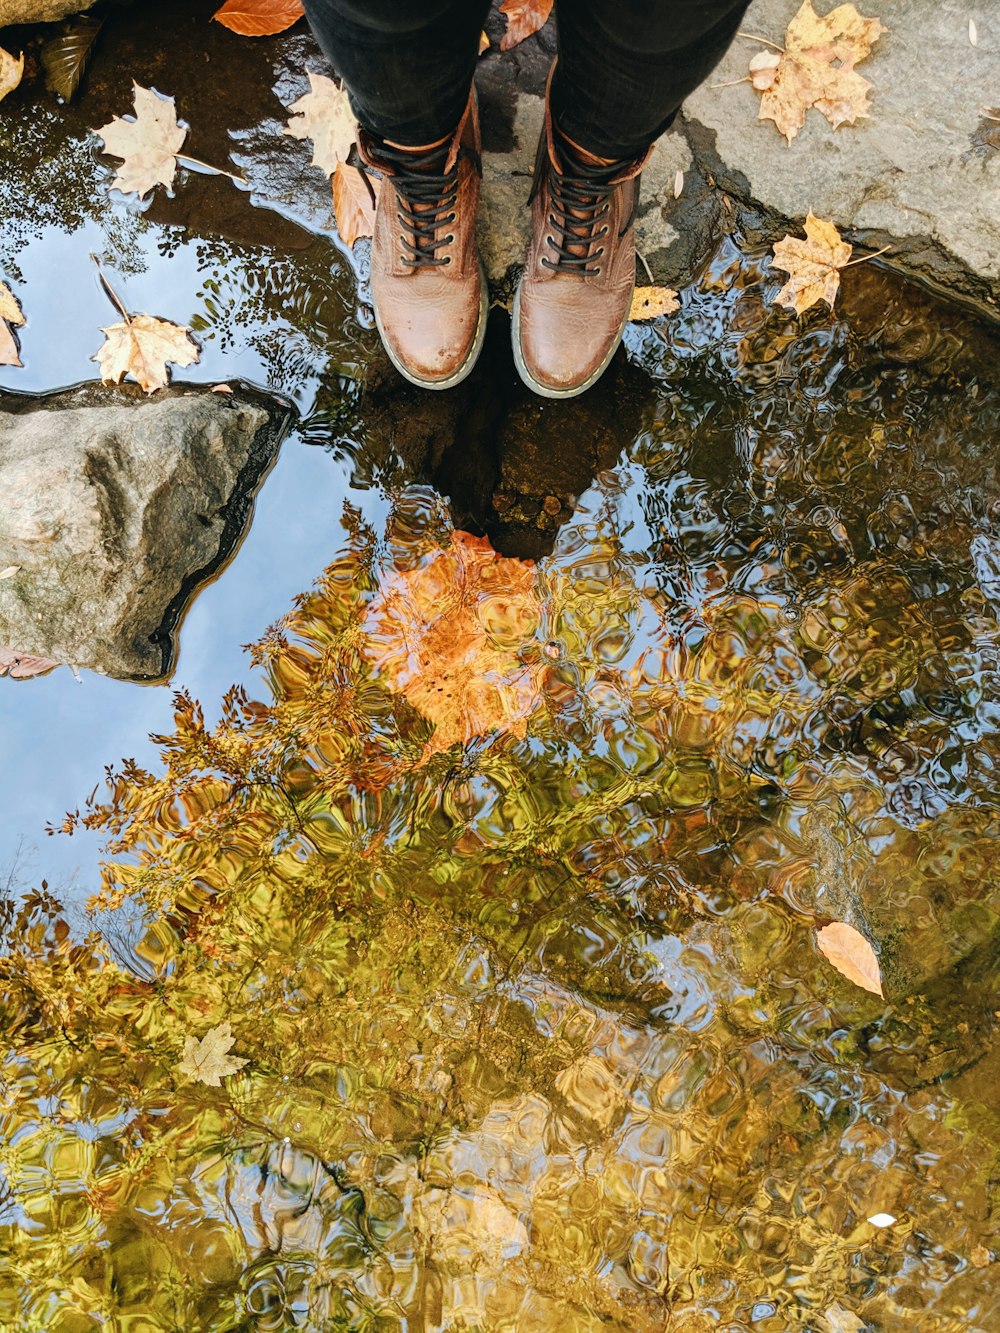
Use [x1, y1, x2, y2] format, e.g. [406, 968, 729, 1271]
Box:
[749, 0, 885, 144]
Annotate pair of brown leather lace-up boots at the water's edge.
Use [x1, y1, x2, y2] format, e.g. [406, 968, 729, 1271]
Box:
[359, 79, 648, 399]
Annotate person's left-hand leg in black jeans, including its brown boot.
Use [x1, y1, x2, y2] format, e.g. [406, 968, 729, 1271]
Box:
[305, 0, 489, 389]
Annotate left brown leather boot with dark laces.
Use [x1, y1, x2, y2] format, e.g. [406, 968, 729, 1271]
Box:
[357, 91, 489, 389]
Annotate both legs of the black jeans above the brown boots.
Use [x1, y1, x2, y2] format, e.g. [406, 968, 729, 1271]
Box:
[305, 0, 749, 159]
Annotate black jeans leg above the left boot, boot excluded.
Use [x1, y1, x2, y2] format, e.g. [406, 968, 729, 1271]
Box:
[304, 0, 489, 147]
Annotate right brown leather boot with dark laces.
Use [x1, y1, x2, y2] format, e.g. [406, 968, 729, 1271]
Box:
[512, 96, 652, 399]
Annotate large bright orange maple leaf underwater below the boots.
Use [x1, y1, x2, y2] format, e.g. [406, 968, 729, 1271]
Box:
[364, 532, 544, 757]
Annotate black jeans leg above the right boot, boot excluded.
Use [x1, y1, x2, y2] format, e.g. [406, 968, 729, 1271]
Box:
[552, 0, 749, 160]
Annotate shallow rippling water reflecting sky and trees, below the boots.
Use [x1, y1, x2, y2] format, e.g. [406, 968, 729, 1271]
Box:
[0, 2, 1000, 1333]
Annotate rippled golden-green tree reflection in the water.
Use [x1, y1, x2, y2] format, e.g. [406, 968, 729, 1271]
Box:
[0, 341, 1000, 1333]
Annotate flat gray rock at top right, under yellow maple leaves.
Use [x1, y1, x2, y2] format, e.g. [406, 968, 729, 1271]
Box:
[683, 0, 1000, 315]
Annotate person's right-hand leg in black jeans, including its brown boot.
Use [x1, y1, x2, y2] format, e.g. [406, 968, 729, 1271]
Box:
[512, 0, 748, 399]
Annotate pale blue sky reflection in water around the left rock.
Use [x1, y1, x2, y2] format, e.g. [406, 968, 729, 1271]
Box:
[0, 196, 381, 900]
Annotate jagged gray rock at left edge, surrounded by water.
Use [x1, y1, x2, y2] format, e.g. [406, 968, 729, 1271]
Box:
[0, 385, 289, 680]
